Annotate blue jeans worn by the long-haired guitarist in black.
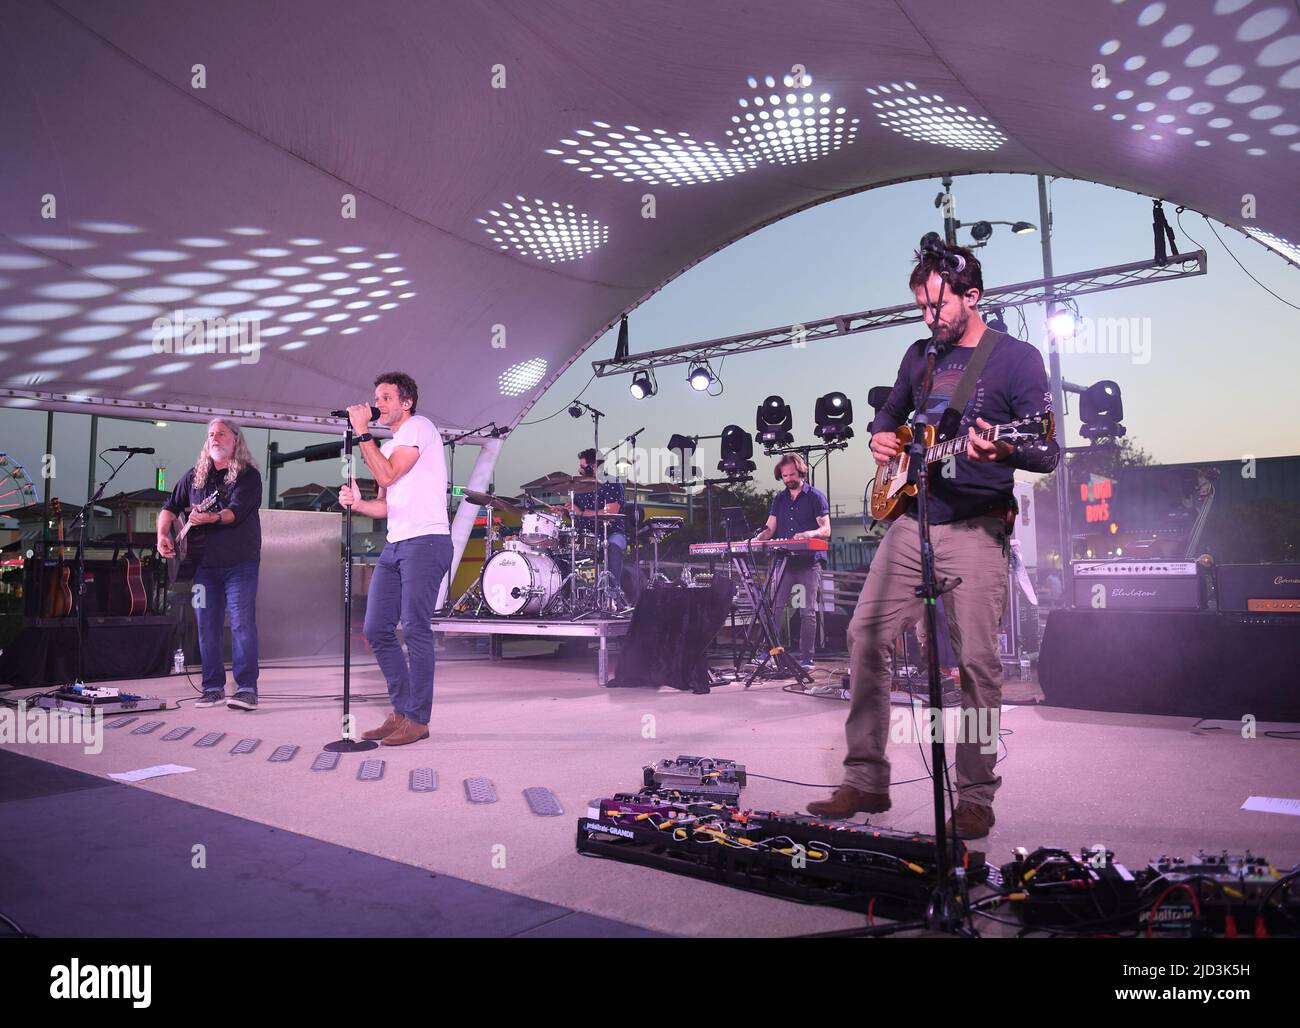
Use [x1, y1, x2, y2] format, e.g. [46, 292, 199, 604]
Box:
[194, 560, 260, 694]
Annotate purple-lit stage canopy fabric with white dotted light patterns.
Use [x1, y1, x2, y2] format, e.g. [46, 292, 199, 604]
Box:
[0, 0, 1300, 428]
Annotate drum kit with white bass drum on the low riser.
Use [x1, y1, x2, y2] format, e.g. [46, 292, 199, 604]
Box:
[454, 472, 655, 621]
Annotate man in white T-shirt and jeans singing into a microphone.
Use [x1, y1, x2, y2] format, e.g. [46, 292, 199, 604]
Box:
[338, 372, 451, 746]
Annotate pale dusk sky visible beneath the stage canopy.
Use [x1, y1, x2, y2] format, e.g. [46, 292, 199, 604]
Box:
[0, 175, 1300, 515]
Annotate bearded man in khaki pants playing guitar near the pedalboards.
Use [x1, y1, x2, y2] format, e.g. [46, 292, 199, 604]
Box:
[807, 247, 1061, 838]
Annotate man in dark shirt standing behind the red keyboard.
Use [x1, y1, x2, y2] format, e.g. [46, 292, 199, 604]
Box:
[754, 454, 831, 671]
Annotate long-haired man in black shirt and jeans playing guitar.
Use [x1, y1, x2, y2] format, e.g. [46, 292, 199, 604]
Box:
[157, 417, 261, 711]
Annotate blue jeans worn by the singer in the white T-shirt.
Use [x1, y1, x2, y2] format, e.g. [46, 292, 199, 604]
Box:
[365, 535, 451, 725]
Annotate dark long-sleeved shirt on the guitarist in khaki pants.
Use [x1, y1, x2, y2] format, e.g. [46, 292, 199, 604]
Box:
[871, 329, 1061, 525]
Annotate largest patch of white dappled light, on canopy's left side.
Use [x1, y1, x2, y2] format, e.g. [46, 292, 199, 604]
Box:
[0, 222, 416, 396]
